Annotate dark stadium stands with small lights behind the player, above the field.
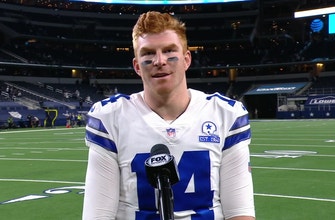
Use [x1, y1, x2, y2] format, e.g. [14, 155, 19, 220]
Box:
[0, 0, 335, 125]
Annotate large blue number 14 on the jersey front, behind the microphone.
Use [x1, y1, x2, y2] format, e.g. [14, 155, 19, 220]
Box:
[131, 151, 214, 220]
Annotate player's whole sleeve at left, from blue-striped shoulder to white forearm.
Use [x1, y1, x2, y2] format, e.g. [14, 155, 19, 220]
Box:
[82, 100, 120, 220]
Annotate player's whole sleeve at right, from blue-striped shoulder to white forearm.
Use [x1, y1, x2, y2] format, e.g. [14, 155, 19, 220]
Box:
[220, 102, 255, 219]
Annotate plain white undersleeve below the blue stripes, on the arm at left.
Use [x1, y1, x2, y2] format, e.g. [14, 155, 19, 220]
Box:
[82, 146, 120, 220]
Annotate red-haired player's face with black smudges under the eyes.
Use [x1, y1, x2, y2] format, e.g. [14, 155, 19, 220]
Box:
[133, 30, 191, 94]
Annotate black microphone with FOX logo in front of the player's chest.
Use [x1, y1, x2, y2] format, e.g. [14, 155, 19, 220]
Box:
[145, 144, 179, 220]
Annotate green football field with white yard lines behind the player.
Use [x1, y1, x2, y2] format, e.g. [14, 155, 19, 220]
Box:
[0, 120, 335, 220]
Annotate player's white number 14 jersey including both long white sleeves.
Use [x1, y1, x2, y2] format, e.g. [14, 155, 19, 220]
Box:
[83, 89, 255, 220]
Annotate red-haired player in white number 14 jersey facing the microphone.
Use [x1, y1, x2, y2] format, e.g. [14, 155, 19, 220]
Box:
[82, 11, 255, 220]
